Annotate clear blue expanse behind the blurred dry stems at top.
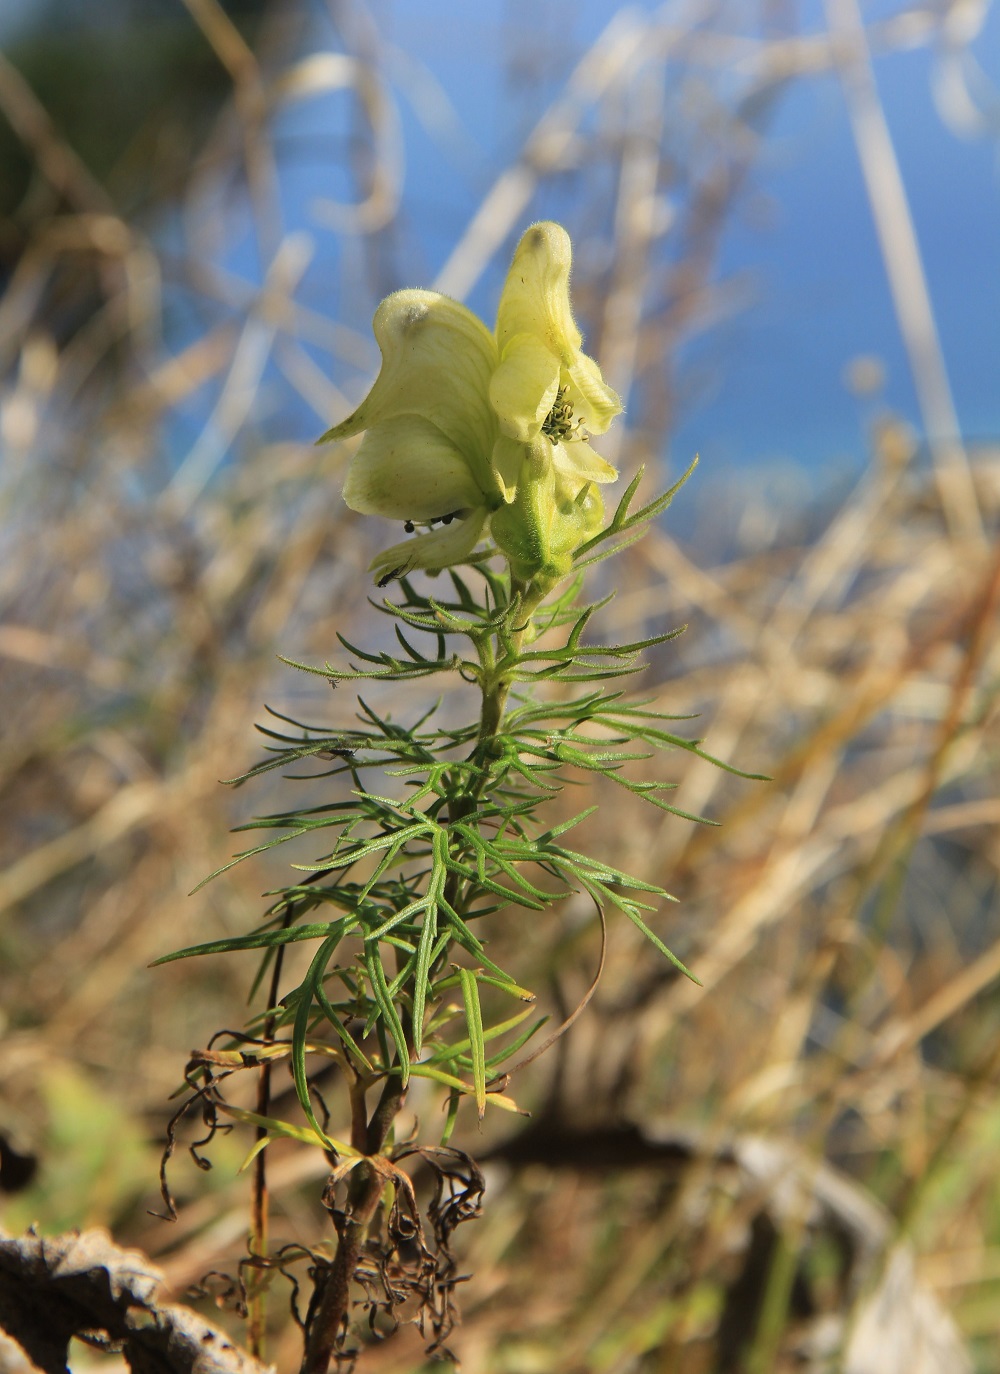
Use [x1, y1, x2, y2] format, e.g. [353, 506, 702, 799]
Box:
[0, 0, 1000, 478]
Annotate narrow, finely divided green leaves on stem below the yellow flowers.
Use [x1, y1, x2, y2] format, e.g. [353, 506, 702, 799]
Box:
[152, 478, 752, 1150]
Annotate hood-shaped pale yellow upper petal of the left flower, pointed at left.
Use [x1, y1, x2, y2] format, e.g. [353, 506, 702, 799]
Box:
[323, 291, 499, 491]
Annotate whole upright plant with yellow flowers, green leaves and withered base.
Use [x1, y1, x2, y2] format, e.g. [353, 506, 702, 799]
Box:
[154, 224, 758, 1374]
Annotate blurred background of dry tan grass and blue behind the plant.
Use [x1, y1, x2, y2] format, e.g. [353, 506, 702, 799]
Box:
[0, 0, 1000, 1374]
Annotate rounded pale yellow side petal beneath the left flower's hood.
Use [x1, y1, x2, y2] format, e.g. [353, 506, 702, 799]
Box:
[343, 415, 484, 521]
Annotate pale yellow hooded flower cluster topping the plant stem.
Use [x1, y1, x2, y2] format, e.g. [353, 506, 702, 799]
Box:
[323, 223, 621, 583]
